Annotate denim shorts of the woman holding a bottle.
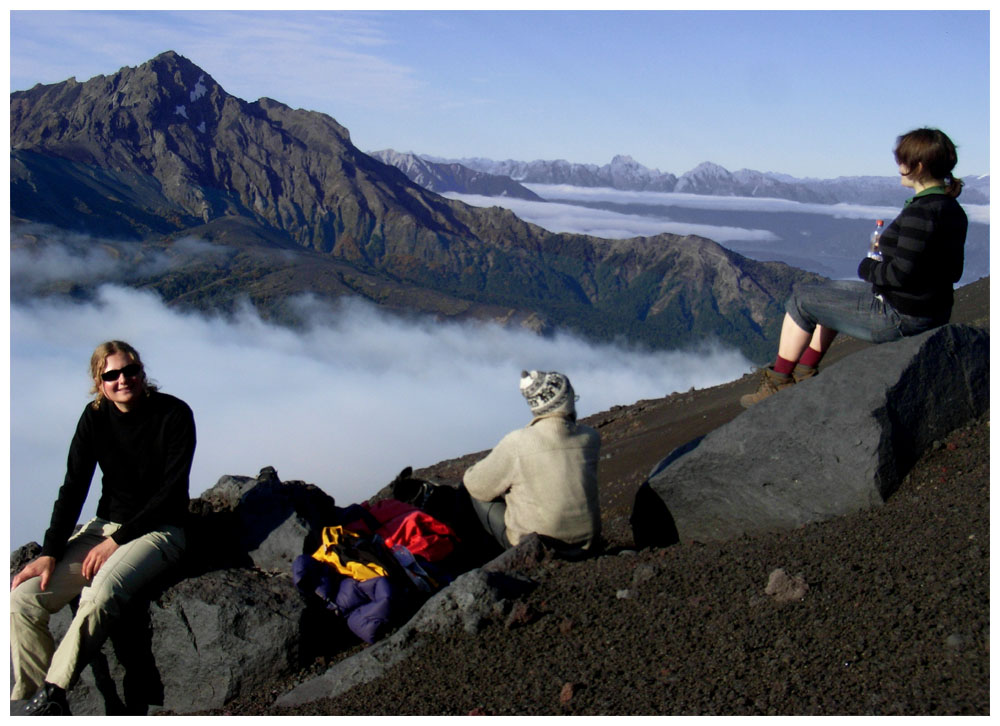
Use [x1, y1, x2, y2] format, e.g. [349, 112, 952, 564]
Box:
[785, 280, 948, 343]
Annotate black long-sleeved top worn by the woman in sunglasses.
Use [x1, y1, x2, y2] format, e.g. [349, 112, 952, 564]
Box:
[42, 392, 195, 559]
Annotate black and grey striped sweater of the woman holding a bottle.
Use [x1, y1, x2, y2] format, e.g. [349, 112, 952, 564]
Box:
[858, 187, 969, 322]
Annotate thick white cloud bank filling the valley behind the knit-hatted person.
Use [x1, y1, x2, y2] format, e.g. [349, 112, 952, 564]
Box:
[10, 286, 750, 547]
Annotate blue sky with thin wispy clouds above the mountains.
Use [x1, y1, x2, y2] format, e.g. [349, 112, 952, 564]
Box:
[10, 10, 990, 178]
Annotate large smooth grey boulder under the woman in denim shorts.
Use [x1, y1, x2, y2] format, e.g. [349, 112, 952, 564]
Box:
[632, 325, 990, 544]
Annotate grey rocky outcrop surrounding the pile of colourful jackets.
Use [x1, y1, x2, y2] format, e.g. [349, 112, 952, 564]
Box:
[5, 467, 524, 715]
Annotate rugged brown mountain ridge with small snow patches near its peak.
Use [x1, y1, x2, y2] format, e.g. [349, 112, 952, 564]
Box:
[11, 51, 812, 358]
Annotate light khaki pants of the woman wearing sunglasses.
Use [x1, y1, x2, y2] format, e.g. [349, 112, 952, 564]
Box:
[10, 518, 185, 700]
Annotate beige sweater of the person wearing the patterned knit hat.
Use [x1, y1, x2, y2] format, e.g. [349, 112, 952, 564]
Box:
[463, 413, 601, 549]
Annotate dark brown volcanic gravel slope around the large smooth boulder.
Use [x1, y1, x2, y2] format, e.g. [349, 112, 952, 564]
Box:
[203, 279, 990, 715]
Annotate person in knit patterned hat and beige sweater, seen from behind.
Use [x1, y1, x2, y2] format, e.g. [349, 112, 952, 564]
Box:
[463, 371, 601, 555]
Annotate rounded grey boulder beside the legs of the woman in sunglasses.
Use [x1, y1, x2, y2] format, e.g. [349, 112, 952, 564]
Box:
[51, 569, 304, 715]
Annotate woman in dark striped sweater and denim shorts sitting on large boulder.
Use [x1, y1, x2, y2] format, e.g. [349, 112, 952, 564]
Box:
[740, 129, 969, 408]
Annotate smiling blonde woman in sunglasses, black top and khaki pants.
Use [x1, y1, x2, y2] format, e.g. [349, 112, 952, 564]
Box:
[10, 340, 195, 715]
